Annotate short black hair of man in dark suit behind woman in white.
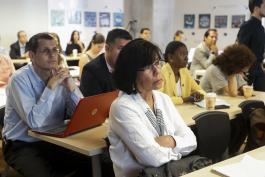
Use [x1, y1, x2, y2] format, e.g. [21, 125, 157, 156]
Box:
[106, 28, 132, 44]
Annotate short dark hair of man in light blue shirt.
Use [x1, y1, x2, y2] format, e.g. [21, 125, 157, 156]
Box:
[27, 33, 55, 53]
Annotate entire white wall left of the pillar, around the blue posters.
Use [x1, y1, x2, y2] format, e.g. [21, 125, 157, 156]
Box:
[0, 0, 123, 50]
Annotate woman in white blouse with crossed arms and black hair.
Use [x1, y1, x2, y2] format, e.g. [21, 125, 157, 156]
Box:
[108, 39, 197, 177]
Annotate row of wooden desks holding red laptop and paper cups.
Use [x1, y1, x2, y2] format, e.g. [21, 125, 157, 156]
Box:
[29, 92, 265, 177]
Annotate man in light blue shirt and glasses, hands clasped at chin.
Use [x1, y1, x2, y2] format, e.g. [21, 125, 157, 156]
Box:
[2, 33, 91, 177]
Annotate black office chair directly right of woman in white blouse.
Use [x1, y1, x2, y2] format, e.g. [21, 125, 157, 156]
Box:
[193, 111, 230, 163]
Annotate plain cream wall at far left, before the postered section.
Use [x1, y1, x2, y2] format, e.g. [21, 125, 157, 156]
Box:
[0, 0, 48, 49]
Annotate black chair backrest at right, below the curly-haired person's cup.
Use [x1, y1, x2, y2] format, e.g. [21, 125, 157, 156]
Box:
[239, 100, 264, 119]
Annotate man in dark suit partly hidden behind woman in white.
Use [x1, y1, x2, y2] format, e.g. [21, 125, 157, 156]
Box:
[80, 29, 132, 96]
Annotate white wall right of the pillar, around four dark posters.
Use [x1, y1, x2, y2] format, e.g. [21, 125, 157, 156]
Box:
[171, 0, 250, 50]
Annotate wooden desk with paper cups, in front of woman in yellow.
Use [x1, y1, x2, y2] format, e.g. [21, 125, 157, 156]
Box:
[176, 91, 265, 126]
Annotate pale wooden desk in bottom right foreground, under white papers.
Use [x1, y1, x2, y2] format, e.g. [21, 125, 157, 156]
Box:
[183, 146, 265, 177]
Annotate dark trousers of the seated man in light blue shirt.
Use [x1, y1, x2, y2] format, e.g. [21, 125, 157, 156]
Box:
[3, 140, 92, 177]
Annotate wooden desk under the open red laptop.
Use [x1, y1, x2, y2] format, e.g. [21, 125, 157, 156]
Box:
[28, 124, 107, 177]
